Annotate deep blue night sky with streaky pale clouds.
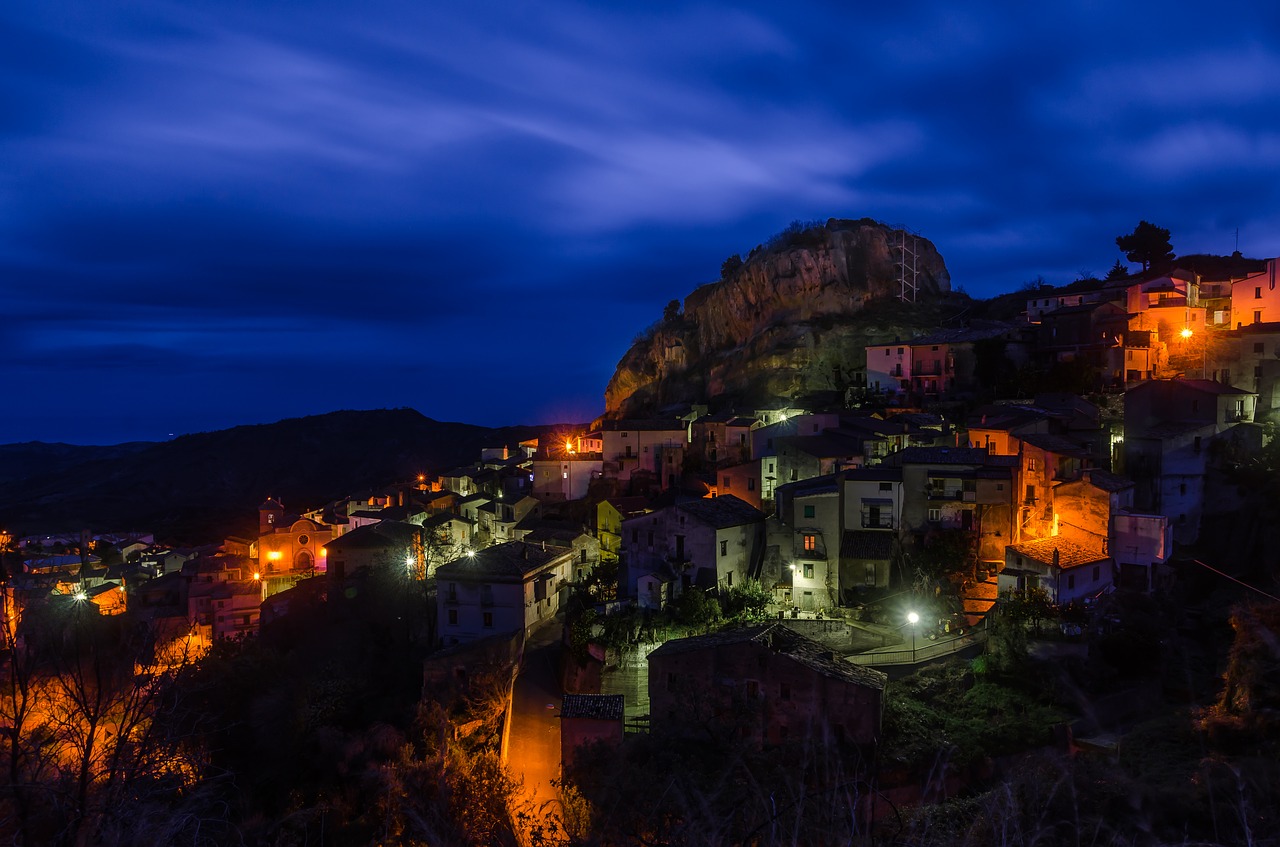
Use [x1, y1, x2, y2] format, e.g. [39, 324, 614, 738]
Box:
[0, 0, 1280, 444]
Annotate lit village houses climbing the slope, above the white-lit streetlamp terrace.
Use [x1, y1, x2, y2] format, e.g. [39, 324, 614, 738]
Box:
[5, 260, 1280, 721]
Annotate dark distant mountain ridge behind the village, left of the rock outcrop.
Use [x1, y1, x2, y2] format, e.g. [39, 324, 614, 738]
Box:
[0, 408, 565, 544]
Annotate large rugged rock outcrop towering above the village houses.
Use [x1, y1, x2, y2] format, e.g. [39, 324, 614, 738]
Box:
[604, 219, 951, 417]
